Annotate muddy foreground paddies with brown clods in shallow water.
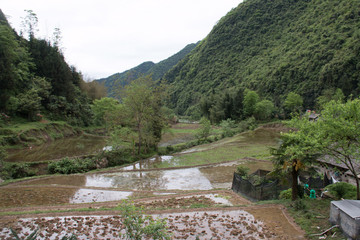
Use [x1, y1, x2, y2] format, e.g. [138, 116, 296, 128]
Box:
[0, 190, 304, 239]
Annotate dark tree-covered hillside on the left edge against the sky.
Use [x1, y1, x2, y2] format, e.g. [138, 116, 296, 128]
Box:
[0, 10, 104, 125]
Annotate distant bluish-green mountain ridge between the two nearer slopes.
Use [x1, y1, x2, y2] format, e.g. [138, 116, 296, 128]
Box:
[96, 43, 197, 97]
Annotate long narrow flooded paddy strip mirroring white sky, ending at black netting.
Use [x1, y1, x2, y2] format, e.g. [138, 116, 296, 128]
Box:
[19, 160, 272, 191]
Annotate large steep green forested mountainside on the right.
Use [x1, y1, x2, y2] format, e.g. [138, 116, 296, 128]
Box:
[164, 0, 360, 114]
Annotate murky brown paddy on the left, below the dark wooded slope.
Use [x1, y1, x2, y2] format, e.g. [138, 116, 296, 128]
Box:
[6, 135, 106, 162]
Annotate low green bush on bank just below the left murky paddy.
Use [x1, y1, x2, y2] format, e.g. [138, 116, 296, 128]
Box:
[48, 157, 96, 174]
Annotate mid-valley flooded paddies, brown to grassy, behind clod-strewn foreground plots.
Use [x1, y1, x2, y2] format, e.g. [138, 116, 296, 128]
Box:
[0, 126, 278, 207]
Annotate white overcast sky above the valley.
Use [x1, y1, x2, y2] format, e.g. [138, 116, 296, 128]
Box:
[0, 0, 242, 79]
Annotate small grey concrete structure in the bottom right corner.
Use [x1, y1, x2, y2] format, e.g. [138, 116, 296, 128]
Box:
[329, 200, 360, 240]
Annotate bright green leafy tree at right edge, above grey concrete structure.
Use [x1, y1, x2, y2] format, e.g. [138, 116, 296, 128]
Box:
[312, 98, 360, 200]
